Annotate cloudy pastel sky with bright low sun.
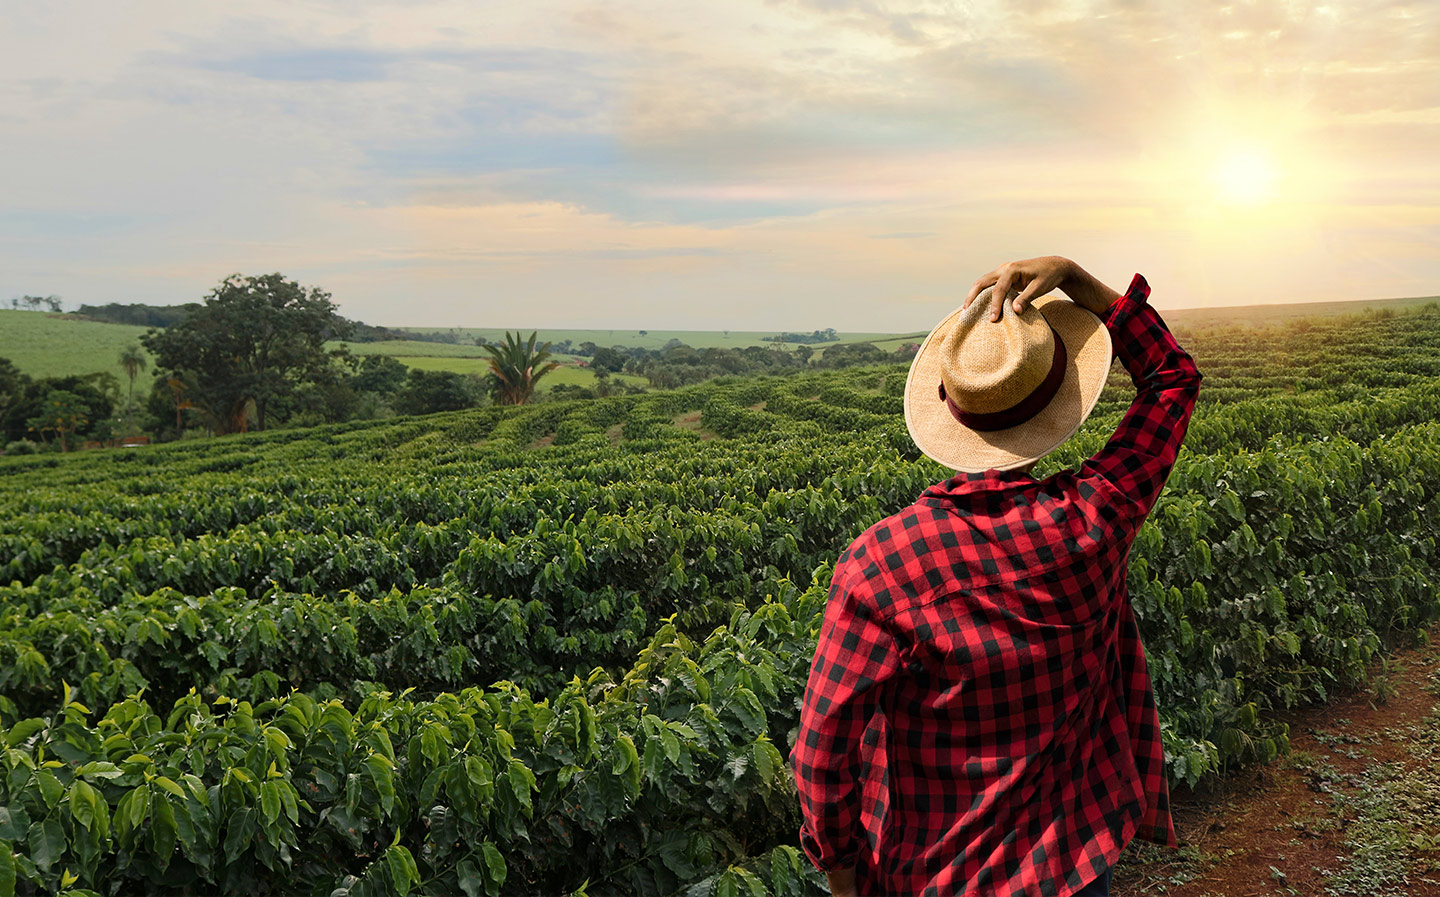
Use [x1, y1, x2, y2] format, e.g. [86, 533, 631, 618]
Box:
[0, 0, 1440, 333]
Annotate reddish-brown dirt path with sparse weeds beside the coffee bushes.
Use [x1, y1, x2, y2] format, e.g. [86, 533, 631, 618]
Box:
[1110, 625, 1440, 897]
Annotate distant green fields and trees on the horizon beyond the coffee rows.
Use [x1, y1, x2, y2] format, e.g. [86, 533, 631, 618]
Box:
[0, 282, 1426, 451]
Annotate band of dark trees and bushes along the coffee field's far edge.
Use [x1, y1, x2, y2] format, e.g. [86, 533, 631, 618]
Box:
[0, 272, 914, 452]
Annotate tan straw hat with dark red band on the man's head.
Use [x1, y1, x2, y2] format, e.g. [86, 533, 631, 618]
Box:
[904, 288, 1113, 472]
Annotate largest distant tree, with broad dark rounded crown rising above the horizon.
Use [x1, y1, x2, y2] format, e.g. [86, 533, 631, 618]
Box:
[141, 274, 348, 433]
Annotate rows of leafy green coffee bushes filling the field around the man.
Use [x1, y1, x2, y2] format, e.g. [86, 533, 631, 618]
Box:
[0, 305, 1440, 897]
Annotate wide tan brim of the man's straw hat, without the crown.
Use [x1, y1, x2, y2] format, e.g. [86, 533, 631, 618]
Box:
[904, 294, 1115, 472]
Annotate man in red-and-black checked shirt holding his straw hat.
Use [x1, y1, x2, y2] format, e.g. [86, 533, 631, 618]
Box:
[791, 256, 1201, 897]
